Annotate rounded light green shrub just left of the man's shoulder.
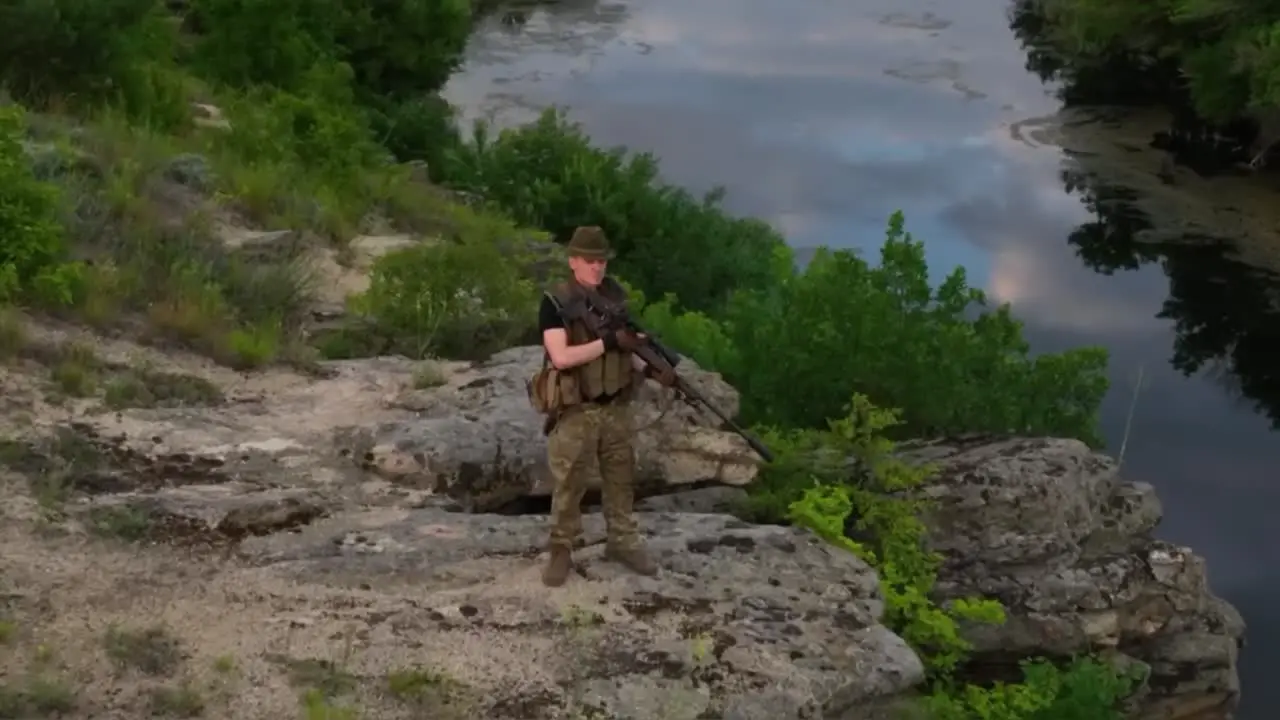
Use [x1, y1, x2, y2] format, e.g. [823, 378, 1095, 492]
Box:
[352, 238, 538, 359]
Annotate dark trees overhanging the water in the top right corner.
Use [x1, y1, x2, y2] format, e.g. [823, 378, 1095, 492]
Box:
[1011, 0, 1280, 172]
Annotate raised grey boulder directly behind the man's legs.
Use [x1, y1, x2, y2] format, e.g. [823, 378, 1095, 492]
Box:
[353, 346, 759, 511]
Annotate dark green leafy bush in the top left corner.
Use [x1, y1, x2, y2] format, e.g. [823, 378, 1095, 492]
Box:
[0, 0, 186, 127]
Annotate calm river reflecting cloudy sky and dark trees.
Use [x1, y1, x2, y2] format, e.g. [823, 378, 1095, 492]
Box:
[447, 0, 1280, 720]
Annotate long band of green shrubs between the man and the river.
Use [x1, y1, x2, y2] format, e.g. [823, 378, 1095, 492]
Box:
[443, 111, 1108, 445]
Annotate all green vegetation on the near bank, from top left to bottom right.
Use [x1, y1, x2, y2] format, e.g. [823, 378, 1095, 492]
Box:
[0, 0, 1138, 720]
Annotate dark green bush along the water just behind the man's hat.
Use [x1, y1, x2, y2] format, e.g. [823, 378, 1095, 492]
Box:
[440, 110, 790, 310]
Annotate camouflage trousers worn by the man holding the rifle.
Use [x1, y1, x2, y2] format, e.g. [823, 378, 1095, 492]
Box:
[547, 402, 639, 550]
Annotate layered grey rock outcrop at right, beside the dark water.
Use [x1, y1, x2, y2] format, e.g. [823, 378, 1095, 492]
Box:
[909, 438, 1244, 720]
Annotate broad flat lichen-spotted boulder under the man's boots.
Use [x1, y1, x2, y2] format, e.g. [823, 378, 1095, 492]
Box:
[241, 509, 923, 720]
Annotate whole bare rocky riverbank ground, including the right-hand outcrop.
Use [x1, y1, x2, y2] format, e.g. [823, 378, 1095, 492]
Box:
[0, 315, 1242, 720]
